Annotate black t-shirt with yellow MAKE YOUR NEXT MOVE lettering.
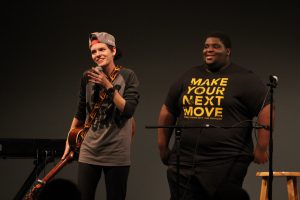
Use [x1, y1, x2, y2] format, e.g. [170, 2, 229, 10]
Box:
[165, 64, 268, 165]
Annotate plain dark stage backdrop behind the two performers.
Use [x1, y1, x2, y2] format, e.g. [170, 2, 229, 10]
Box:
[0, 1, 300, 200]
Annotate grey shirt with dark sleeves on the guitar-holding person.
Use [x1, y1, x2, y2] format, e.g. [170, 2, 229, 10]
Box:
[75, 68, 139, 166]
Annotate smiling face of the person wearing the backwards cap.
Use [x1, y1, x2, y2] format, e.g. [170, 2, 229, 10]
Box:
[91, 43, 116, 67]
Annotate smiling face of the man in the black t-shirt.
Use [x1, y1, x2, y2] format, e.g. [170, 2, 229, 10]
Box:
[203, 37, 230, 67]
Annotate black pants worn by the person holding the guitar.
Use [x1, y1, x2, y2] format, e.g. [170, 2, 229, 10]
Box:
[78, 162, 130, 200]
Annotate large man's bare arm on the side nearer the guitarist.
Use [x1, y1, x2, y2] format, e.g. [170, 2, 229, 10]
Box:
[157, 105, 176, 165]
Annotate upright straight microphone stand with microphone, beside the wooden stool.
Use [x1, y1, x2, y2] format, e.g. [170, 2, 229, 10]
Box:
[267, 75, 278, 200]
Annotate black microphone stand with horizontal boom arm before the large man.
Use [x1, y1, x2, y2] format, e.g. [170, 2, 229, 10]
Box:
[145, 124, 266, 200]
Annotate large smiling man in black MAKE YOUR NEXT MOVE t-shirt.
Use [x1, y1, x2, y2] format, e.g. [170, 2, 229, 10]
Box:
[158, 32, 270, 200]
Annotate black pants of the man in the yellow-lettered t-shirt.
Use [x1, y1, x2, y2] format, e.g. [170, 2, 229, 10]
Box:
[167, 160, 249, 200]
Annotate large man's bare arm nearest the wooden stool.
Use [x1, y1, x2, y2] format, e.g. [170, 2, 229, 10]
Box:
[254, 105, 274, 164]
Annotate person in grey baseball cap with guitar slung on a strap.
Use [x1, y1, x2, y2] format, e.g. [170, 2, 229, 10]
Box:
[62, 32, 139, 200]
